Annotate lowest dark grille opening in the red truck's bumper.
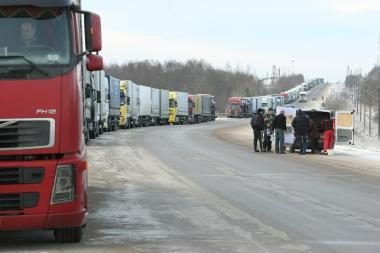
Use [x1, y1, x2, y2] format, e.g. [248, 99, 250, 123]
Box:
[0, 192, 40, 211]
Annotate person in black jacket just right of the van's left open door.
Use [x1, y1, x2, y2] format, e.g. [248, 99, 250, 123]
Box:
[292, 110, 309, 155]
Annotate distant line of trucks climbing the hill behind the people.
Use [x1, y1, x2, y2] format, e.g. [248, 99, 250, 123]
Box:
[225, 78, 324, 118]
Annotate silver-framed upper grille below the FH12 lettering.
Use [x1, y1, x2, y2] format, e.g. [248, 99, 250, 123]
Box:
[0, 119, 54, 150]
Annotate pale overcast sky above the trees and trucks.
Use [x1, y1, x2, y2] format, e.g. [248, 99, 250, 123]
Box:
[83, 0, 380, 81]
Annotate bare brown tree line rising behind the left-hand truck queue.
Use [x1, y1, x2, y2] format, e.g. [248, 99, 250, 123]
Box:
[106, 60, 304, 112]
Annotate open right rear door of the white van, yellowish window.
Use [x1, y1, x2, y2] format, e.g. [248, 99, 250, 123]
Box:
[335, 111, 354, 145]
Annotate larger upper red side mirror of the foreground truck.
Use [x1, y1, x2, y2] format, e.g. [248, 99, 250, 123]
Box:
[84, 12, 102, 53]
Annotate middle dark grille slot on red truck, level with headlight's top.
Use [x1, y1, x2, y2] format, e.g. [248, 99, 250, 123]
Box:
[0, 168, 44, 185]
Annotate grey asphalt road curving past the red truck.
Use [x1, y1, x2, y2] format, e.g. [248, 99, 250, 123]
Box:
[0, 119, 380, 253]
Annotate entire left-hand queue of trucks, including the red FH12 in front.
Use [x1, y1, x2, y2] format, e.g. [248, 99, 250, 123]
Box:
[0, 0, 215, 243]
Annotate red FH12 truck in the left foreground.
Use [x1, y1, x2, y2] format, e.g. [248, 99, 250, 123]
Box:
[0, 0, 103, 243]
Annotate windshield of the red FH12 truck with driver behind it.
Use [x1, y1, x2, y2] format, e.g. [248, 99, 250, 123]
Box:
[0, 6, 70, 67]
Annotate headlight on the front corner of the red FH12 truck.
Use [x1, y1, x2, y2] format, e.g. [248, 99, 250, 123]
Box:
[52, 165, 74, 204]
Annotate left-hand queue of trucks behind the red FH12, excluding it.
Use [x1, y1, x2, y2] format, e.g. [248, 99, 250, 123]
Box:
[84, 71, 216, 141]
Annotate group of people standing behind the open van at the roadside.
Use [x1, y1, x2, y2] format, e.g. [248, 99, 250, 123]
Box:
[251, 108, 334, 155]
